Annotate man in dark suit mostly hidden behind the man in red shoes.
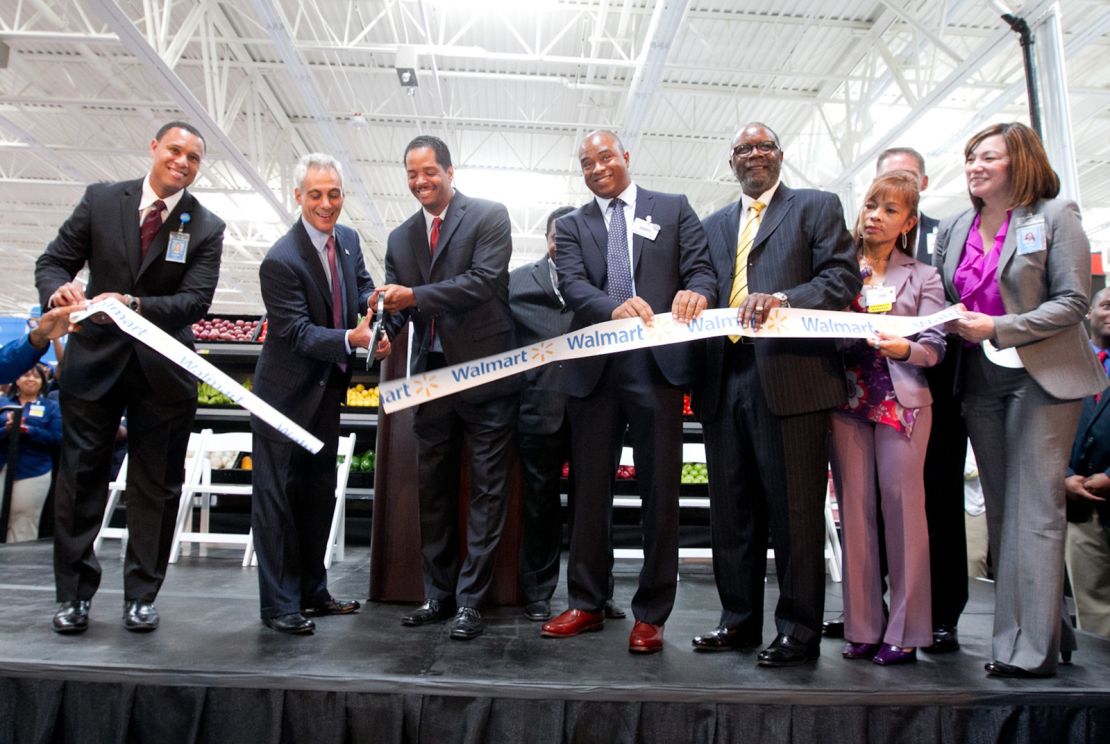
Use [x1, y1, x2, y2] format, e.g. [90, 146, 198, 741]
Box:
[508, 207, 625, 622]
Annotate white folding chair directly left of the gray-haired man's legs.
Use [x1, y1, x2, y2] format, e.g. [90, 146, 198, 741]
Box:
[170, 429, 256, 566]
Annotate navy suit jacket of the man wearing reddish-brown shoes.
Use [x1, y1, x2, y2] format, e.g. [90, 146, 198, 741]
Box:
[555, 188, 717, 398]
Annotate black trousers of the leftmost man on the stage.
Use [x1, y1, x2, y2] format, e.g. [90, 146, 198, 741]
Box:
[54, 356, 196, 602]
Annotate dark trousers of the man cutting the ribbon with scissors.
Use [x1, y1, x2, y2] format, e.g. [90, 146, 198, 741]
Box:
[415, 393, 517, 607]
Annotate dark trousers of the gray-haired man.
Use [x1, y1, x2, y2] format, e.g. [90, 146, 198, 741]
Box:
[251, 368, 346, 617]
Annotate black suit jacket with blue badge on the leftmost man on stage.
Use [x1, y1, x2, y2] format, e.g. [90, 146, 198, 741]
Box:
[34, 179, 223, 401]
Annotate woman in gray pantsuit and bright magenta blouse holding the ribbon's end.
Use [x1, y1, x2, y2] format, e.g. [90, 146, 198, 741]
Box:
[934, 122, 1106, 677]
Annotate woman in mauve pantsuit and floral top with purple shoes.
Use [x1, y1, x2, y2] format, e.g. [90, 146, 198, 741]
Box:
[831, 171, 945, 665]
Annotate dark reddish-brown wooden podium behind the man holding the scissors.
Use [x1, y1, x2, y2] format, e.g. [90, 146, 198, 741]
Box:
[370, 326, 522, 605]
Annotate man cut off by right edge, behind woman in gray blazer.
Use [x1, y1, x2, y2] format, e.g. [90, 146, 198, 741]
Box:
[1064, 289, 1110, 639]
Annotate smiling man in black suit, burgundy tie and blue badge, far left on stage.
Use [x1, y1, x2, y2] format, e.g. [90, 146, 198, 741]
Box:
[34, 121, 223, 633]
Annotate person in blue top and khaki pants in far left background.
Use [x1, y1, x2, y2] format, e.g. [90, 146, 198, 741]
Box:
[0, 364, 62, 543]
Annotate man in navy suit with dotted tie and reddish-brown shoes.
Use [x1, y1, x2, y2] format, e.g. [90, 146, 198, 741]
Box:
[543, 131, 717, 653]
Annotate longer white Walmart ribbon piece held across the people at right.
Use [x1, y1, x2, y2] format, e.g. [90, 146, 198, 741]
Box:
[380, 308, 962, 413]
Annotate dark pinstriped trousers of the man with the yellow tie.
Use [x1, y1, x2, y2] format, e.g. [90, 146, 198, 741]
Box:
[704, 344, 829, 643]
